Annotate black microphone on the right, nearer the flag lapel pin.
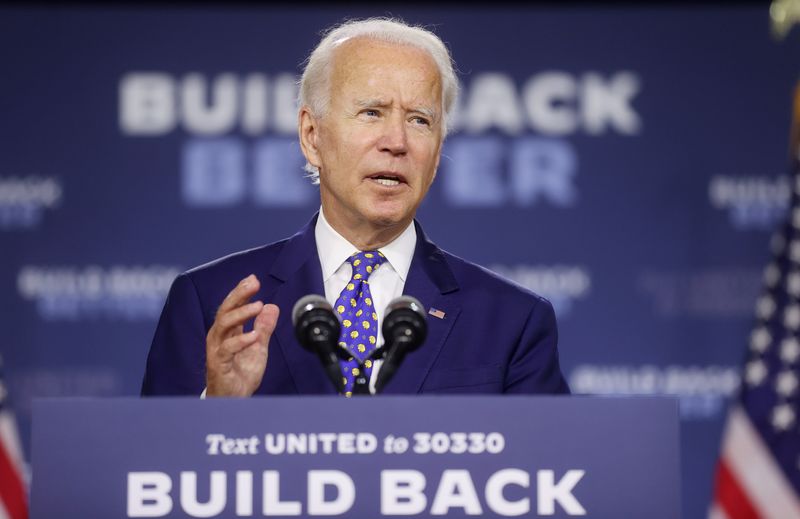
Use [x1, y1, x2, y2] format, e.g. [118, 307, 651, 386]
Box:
[375, 296, 428, 393]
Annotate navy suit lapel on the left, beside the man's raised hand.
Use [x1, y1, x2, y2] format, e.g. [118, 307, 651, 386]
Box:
[267, 215, 336, 394]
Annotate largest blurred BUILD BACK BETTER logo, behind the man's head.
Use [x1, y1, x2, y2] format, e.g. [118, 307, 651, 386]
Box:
[119, 71, 642, 208]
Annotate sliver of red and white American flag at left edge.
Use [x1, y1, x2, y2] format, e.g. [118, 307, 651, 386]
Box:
[0, 359, 28, 519]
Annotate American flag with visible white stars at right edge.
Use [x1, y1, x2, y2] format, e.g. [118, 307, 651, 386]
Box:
[709, 84, 800, 519]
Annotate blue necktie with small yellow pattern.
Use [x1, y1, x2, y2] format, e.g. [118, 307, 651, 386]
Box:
[335, 250, 386, 396]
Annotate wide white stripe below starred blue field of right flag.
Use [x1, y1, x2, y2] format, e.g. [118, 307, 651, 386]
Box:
[722, 405, 800, 518]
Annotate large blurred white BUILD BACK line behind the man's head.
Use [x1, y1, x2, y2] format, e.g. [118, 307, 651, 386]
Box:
[119, 70, 642, 136]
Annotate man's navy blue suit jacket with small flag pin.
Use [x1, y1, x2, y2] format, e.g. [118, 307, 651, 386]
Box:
[142, 217, 569, 395]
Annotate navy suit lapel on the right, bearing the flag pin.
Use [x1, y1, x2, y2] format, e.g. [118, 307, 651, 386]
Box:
[384, 221, 461, 394]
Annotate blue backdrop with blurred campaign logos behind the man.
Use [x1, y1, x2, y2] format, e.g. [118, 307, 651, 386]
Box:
[0, 6, 800, 517]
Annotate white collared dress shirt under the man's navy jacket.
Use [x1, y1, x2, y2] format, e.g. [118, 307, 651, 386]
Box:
[314, 208, 417, 393]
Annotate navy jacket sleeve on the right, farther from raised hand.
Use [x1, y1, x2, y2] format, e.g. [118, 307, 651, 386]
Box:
[503, 298, 570, 394]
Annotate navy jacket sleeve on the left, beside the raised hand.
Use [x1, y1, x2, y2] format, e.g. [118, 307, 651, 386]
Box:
[142, 273, 207, 397]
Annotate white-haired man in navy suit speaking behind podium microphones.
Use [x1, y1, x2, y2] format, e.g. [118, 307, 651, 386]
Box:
[142, 19, 569, 396]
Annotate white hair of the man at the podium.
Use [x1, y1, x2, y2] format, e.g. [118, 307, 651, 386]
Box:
[298, 18, 458, 184]
